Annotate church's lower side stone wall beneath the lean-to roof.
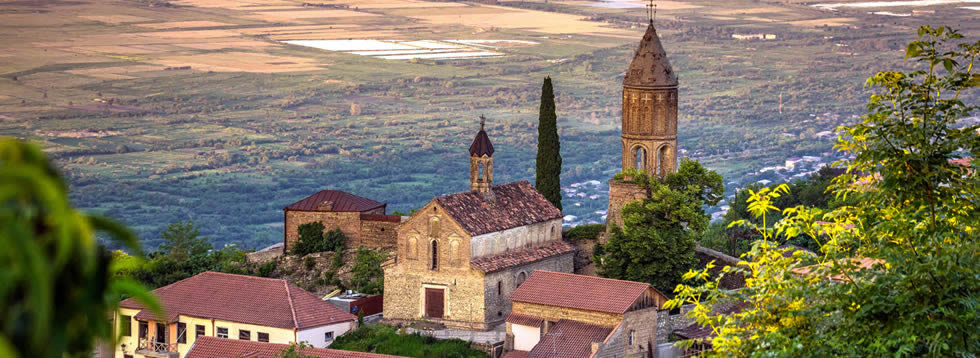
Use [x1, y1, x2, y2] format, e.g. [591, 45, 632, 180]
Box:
[483, 252, 574, 326]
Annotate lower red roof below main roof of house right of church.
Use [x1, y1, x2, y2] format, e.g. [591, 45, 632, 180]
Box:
[527, 319, 612, 358]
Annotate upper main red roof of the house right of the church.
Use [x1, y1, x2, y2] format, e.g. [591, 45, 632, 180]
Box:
[510, 270, 650, 313]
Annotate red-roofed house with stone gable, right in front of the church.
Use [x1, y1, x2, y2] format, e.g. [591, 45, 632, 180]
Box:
[505, 271, 667, 358]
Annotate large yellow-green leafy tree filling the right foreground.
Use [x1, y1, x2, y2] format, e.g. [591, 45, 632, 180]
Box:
[668, 26, 980, 357]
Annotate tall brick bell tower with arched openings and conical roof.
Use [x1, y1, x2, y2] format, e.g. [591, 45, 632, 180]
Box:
[605, 17, 677, 236]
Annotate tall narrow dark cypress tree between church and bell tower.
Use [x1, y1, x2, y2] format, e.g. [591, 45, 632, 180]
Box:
[534, 77, 561, 210]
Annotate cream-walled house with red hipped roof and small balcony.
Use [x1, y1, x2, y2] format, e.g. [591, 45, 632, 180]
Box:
[115, 272, 357, 358]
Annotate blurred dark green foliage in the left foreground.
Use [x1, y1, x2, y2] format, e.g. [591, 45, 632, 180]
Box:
[0, 139, 160, 358]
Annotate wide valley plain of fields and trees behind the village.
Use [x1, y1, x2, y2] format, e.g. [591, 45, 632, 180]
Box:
[0, 0, 980, 248]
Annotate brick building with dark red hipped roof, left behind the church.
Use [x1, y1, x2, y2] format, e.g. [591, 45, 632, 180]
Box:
[282, 190, 401, 253]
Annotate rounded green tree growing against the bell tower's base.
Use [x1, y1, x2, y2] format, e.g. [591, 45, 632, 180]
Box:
[595, 158, 724, 292]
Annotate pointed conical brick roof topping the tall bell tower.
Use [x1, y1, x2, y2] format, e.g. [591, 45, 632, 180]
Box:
[623, 23, 677, 87]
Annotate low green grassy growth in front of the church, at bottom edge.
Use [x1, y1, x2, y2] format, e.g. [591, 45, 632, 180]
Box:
[330, 324, 489, 358]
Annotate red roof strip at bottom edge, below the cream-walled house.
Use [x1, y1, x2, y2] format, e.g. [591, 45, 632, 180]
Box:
[184, 336, 397, 358]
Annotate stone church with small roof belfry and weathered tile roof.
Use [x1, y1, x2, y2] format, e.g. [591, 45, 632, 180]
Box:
[384, 120, 575, 330]
